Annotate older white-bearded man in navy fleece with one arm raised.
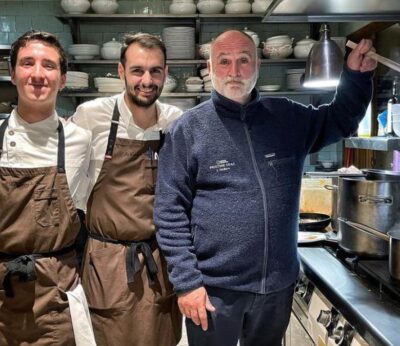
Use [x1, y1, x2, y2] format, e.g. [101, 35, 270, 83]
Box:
[155, 30, 376, 346]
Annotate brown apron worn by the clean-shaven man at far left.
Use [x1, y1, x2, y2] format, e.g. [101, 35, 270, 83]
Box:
[0, 119, 80, 345]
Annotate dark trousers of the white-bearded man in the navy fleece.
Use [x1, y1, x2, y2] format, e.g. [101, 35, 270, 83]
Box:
[186, 284, 294, 346]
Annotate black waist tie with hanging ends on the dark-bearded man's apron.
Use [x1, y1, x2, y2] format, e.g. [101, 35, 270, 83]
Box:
[89, 233, 158, 286]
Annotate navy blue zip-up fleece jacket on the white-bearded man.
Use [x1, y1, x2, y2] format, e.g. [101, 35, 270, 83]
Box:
[155, 68, 372, 294]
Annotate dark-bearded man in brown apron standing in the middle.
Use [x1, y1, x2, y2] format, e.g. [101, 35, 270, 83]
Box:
[73, 33, 182, 346]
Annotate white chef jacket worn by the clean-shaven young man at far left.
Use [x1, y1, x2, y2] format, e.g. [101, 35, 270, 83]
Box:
[0, 109, 91, 209]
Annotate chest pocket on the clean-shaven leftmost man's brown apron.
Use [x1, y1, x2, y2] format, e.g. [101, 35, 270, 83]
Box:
[33, 189, 60, 227]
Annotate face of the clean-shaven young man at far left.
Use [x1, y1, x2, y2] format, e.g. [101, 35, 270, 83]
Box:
[11, 40, 66, 109]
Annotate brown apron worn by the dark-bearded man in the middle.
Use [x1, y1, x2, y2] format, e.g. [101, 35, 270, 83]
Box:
[82, 105, 182, 346]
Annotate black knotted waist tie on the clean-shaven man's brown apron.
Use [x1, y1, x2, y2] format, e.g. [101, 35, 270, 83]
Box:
[0, 245, 74, 298]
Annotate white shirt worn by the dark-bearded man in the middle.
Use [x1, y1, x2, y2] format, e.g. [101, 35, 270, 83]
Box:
[71, 92, 182, 198]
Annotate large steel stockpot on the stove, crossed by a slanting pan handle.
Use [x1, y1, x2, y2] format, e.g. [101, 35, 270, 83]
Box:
[338, 171, 400, 257]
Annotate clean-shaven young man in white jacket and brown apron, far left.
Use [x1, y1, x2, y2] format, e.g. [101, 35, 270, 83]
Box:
[0, 31, 95, 345]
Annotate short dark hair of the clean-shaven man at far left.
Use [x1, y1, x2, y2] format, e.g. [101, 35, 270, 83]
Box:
[10, 30, 68, 75]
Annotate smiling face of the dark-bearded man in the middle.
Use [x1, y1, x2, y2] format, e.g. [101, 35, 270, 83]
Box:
[118, 43, 167, 108]
